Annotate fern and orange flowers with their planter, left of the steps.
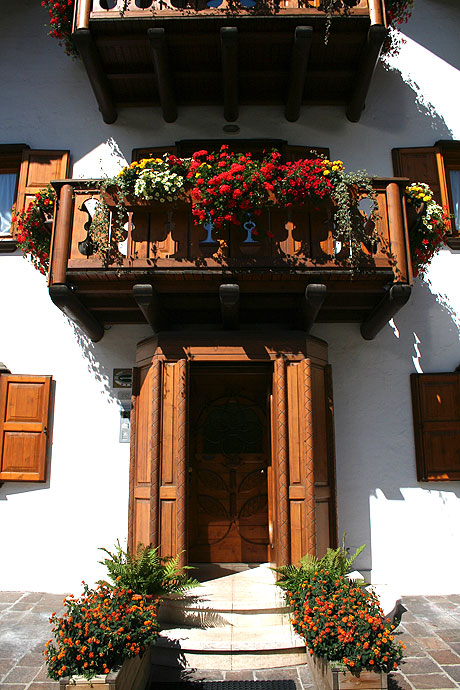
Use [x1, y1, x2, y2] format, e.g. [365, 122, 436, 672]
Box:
[45, 543, 197, 690]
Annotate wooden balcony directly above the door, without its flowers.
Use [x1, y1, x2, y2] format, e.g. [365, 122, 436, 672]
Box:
[49, 178, 412, 340]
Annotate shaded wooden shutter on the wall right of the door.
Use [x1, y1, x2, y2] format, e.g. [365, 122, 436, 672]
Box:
[411, 373, 460, 482]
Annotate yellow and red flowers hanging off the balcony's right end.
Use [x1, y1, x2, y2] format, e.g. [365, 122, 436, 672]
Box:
[405, 182, 451, 276]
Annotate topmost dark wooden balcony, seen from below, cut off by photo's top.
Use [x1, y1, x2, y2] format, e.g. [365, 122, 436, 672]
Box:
[73, 0, 386, 123]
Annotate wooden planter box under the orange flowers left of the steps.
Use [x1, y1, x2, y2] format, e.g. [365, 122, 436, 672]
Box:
[59, 647, 152, 690]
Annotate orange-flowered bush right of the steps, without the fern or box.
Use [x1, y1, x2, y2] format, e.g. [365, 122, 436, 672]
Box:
[285, 568, 404, 676]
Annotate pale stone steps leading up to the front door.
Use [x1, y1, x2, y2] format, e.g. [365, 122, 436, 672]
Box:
[153, 565, 306, 670]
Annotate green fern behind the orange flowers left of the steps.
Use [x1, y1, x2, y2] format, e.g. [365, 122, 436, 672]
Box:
[99, 541, 199, 596]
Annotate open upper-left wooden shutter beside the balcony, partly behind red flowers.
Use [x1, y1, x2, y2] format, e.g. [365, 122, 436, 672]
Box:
[16, 149, 69, 216]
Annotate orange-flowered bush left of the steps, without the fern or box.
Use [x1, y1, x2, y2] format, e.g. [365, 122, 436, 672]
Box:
[45, 583, 158, 680]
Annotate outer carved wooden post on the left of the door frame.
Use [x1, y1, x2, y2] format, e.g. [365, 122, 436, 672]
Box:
[149, 357, 163, 546]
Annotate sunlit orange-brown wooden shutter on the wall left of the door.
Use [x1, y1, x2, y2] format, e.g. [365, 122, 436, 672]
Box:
[0, 374, 52, 482]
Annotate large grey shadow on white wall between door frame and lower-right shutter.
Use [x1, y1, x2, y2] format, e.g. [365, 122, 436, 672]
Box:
[313, 280, 460, 574]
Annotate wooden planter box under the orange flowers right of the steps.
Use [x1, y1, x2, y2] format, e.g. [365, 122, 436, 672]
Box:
[307, 651, 388, 690]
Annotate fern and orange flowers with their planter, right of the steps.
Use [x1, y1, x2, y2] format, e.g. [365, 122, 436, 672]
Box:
[277, 546, 404, 690]
